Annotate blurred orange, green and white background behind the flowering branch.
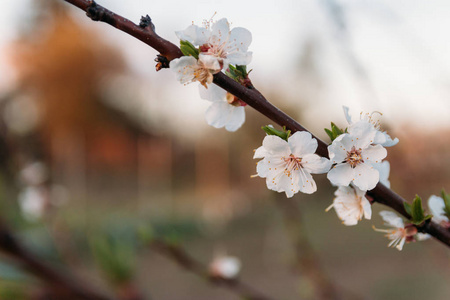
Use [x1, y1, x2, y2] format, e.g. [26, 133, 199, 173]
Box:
[0, 0, 450, 300]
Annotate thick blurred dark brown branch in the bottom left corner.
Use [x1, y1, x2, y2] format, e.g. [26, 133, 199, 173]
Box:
[0, 220, 111, 300]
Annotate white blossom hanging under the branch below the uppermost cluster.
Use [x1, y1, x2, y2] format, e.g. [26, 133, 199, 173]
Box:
[199, 85, 246, 131]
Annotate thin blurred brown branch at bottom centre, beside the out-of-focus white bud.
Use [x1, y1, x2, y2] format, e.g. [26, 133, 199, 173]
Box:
[150, 240, 272, 300]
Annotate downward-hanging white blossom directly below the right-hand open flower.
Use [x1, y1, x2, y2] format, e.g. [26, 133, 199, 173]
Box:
[327, 186, 372, 226]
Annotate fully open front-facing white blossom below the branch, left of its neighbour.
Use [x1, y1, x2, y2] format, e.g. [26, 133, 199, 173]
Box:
[253, 131, 330, 198]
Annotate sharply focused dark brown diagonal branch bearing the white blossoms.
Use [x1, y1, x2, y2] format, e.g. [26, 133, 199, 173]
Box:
[64, 0, 450, 247]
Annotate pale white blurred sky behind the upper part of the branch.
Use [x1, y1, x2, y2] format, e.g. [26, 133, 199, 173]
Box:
[0, 0, 450, 136]
